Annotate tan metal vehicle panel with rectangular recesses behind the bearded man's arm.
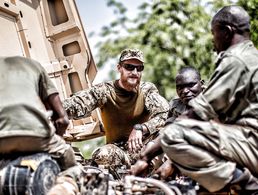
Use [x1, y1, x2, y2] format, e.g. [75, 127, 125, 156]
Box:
[0, 0, 104, 141]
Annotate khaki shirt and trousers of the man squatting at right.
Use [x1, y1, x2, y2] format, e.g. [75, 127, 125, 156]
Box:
[161, 41, 258, 191]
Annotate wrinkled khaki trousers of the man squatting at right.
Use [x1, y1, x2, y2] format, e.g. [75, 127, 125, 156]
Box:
[161, 119, 258, 192]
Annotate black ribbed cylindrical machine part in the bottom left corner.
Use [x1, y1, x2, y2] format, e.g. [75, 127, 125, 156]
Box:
[0, 153, 60, 195]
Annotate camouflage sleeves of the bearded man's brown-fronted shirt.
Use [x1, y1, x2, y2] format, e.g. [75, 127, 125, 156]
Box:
[63, 81, 169, 134]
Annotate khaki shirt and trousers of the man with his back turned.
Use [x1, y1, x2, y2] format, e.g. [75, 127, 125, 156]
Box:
[0, 56, 72, 170]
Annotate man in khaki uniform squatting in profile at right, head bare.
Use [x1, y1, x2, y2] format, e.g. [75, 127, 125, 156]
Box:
[132, 5, 258, 194]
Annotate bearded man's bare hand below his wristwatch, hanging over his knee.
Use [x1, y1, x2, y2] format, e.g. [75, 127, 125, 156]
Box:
[128, 129, 143, 152]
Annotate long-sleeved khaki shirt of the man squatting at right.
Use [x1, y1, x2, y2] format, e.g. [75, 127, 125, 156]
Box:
[189, 41, 258, 130]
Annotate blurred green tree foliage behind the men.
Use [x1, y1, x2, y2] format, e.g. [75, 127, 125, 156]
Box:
[98, 0, 257, 99]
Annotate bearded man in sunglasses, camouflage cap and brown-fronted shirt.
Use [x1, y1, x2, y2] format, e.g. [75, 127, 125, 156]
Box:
[63, 49, 169, 165]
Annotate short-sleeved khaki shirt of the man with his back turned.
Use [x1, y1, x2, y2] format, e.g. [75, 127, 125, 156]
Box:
[0, 57, 57, 138]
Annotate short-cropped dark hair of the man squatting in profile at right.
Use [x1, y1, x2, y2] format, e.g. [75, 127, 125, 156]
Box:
[211, 5, 250, 33]
